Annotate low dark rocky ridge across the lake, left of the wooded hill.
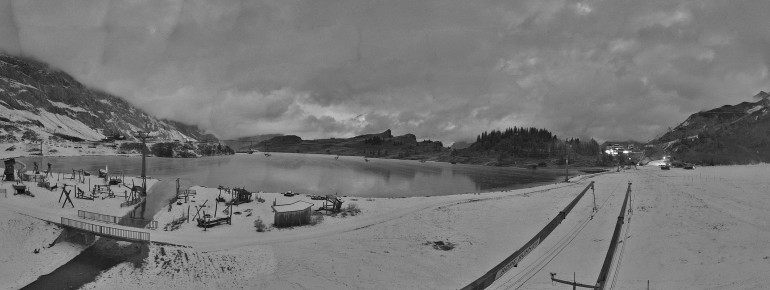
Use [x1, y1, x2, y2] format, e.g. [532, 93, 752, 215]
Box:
[254, 130, 449, 160]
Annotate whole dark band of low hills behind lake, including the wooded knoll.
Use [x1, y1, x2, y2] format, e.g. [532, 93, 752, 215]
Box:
[252, 128, 614, 167]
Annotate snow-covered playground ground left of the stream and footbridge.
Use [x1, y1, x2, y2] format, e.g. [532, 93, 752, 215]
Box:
[0, 174, 156, 289]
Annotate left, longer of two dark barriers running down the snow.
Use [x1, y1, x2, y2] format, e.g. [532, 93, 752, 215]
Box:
[461, 181, 594, 290]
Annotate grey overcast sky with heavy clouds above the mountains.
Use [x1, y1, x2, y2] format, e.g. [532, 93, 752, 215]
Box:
[0, 0, 770, 143]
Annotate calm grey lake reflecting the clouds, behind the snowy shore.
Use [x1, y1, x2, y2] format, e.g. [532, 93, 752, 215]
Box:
[19, 153, 559, 198]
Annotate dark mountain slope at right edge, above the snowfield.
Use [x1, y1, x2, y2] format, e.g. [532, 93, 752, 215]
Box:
[648, 92, 770, 165]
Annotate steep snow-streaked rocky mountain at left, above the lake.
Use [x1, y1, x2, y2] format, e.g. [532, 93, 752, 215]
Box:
[0, 53, 210, 143]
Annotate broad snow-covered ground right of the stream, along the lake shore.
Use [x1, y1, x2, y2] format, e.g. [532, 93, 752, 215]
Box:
[6, 164, 770, 289]
